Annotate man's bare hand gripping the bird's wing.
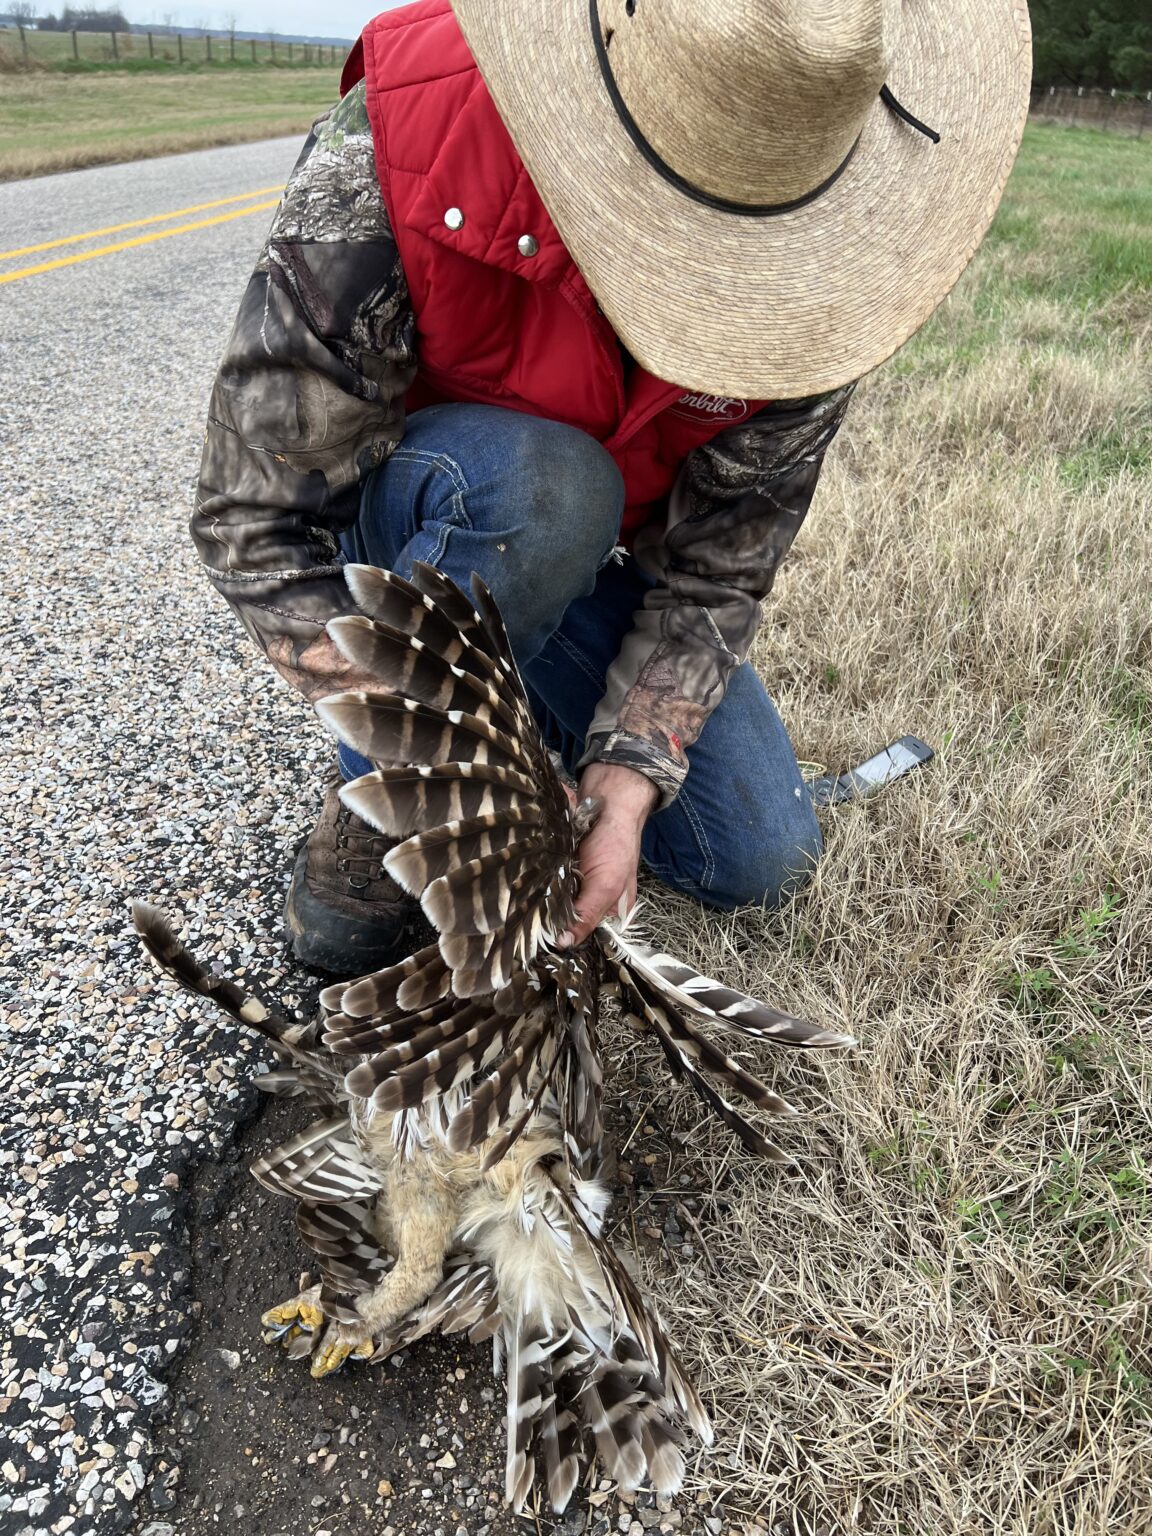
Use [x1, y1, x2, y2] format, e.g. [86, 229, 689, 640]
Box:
[559, 763, 660, 949]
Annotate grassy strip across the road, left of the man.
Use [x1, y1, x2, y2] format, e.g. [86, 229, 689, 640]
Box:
[0, 68, 339, 181]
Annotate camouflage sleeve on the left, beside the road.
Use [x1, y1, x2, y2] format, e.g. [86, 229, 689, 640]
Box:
[192, 83, 415, 696]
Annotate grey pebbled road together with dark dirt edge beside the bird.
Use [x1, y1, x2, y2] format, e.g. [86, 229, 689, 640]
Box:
[0, 140, 720, 1536]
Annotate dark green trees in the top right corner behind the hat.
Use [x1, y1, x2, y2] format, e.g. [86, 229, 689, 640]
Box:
[1029, 0, 1152, 91]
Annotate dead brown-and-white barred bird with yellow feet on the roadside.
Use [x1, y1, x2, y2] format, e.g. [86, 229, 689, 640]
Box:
[134, 565, 851, 1510]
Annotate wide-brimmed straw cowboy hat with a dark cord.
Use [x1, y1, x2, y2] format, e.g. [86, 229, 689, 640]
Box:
[453, 0, 1032, 399]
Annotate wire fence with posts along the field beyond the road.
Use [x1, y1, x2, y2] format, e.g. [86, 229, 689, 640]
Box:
[0, 26, 352, 69]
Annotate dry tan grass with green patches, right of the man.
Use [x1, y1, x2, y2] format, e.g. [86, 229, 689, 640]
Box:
[613, 127, 1152, 1536]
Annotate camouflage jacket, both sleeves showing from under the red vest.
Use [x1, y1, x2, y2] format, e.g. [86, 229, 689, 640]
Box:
[192, 83, 851, 803]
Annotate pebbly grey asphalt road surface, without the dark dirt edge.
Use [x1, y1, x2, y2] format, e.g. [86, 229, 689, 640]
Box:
[0, 140, 442, 1536]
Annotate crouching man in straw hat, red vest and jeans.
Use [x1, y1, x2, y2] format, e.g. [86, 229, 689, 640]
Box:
[192, 0, 1029, 974]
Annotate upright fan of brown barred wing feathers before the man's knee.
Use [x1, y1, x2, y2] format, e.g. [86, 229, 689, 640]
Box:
[316, 564, 576, 998]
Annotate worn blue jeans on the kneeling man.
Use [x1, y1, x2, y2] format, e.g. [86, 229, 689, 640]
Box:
[339, 406, 822, 909]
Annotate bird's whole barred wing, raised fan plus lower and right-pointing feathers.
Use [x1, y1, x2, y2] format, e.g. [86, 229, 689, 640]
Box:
[316, 564, 851, 1177]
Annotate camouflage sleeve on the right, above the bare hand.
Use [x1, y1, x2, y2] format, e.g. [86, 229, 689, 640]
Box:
[582, 386, 854, 805]
